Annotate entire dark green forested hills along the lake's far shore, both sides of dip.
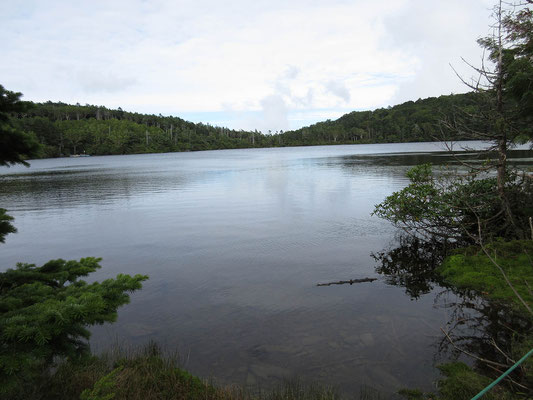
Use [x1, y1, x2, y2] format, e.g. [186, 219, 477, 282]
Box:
[12, 93, 477, 157]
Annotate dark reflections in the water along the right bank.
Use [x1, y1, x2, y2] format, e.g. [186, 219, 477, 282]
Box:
[372, 236, 533, 394]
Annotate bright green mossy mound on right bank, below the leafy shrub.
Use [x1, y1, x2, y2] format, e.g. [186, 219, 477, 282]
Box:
[437, 240, 533, 308]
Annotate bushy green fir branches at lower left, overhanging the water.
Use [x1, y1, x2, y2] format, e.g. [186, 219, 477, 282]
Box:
[0, 257, 148, 393]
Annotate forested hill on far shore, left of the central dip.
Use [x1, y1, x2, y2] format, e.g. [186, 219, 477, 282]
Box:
[12, 102, 270, 157]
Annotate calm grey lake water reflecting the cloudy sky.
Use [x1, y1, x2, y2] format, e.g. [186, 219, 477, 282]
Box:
[0, 143, 532, 393]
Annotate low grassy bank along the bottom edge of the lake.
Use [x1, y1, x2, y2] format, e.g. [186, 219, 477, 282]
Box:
[14, 343, 386, 400]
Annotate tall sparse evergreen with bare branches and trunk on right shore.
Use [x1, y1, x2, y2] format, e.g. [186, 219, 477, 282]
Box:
[448, 0, 533, 231]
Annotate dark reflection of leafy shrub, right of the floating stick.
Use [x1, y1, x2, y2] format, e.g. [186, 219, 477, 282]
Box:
[371, 235, 446, 299]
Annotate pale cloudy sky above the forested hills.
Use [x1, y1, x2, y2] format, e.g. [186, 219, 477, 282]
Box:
[0, 0, 494, 131]
